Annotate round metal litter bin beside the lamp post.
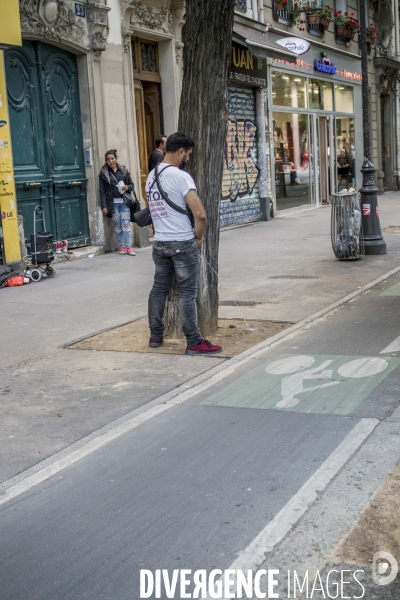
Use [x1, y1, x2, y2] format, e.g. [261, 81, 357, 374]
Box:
[331, 190, 364, 260]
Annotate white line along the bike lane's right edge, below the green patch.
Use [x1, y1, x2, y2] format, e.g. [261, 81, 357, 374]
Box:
[206, 419, 379, 600]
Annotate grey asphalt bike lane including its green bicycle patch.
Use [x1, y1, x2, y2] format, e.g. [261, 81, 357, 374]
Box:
[0, 276, 400, 600]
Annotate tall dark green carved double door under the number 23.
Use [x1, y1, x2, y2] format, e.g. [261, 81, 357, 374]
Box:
[5, 42, 90, 247]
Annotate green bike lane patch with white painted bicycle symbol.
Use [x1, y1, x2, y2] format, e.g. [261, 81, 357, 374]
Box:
[201, 354, 400, 415]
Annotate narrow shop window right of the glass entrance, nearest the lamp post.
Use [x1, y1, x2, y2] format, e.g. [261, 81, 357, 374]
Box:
[335, 117, 356, 192]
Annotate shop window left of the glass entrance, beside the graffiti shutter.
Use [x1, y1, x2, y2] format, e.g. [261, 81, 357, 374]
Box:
[273, 112, 311, 210]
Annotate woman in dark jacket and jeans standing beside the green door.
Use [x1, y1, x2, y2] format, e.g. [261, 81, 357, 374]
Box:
[99, 150, 136, 256]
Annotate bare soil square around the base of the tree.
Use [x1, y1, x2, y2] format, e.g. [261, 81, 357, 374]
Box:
[69, 317, 293, 358]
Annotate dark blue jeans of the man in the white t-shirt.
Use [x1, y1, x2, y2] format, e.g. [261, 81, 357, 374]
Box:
[149, 240, 202, 346]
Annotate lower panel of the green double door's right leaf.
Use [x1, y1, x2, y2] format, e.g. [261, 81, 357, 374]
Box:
[54, 179, 90, 248]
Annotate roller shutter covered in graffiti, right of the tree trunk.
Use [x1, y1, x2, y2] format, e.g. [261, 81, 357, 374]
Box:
[220, 87, 260, 227]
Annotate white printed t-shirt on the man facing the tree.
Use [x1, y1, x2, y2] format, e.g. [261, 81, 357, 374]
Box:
[146, 163, 196, 242]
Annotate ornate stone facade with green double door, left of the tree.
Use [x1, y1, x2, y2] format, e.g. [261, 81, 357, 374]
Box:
[5, 0, 184, 250]
